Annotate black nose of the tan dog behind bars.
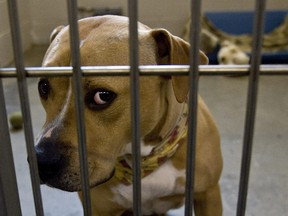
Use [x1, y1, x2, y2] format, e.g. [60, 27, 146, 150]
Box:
[35, 139, 64, 183]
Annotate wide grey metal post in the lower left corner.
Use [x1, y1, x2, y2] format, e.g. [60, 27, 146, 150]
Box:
[0, 79, 21, 216]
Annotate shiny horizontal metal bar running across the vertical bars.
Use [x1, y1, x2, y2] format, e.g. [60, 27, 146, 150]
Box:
[0, 65, 288, 78]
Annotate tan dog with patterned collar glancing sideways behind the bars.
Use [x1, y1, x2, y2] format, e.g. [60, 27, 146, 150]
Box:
[35, 16, 222, 216]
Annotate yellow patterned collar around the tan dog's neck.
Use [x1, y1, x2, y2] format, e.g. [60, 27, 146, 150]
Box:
[115, 103, 188, 185]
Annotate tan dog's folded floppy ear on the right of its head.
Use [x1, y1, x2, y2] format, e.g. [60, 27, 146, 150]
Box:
[151, 29, 208, 103]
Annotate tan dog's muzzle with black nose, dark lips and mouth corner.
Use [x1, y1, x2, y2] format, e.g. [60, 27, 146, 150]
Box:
[35, 138, 114, 192]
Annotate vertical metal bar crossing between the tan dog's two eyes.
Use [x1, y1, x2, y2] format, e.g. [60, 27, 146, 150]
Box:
[67, 0, 91, 215]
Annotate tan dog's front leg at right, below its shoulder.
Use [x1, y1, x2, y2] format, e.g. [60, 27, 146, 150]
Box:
[194, 184, 222, 216]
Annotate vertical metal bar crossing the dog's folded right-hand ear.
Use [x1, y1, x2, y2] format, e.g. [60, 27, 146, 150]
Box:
[185, 0, 201, 216]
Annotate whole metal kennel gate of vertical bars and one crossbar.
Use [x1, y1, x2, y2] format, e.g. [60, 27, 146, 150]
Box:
[0, 0, 288, 216]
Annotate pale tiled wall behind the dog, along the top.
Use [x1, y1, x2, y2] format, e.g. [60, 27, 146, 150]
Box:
[0, 0, 288, 66]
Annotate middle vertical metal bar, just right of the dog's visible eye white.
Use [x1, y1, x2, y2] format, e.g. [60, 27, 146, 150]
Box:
[128, 0, 141, 215]
